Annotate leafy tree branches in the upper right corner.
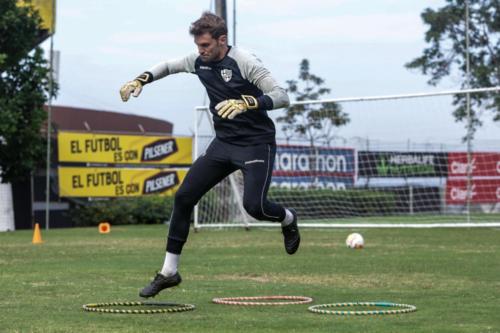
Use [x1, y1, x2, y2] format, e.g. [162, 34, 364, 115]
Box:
[406, 0, 500, 135]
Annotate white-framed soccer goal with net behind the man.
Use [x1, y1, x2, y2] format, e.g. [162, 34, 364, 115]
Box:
[194, 87, 500, 228]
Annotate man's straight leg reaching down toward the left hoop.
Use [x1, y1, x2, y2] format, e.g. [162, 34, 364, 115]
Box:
[139, 141, 236, 297]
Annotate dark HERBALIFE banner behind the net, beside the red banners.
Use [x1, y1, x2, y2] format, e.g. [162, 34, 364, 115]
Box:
[358, 151, 448, 177]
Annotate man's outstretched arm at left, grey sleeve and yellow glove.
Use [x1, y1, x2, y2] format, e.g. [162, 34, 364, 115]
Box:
[120, 53, 198, 102]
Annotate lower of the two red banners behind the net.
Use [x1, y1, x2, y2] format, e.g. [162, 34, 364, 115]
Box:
[446, 178, 500, 205]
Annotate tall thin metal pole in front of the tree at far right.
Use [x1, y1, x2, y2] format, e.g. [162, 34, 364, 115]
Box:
[465, 0, 472, 223]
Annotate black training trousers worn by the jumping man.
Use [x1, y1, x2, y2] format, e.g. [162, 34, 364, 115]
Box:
[167, 138, 285, 254]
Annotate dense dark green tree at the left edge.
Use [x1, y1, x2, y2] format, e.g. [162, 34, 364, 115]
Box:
[0, 0, 54, 182]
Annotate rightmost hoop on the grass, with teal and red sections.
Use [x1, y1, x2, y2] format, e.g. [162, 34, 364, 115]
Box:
[308, 302, 417, 316]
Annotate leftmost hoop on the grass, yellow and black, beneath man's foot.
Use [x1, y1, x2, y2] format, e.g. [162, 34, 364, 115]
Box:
[83, 302, 195, 314]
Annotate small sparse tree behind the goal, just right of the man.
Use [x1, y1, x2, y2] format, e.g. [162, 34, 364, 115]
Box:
[276, 59, 349, 146]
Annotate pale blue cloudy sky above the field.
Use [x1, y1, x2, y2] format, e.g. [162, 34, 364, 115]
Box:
[42, 0, 500, 143]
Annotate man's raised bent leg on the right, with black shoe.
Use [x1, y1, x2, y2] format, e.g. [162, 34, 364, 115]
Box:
[236, 144, 300, 254]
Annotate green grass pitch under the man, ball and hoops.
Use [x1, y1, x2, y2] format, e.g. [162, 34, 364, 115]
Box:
[0, 226, 500, 333]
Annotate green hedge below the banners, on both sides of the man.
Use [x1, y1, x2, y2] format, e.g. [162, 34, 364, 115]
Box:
[69, 188, 397, 226]
